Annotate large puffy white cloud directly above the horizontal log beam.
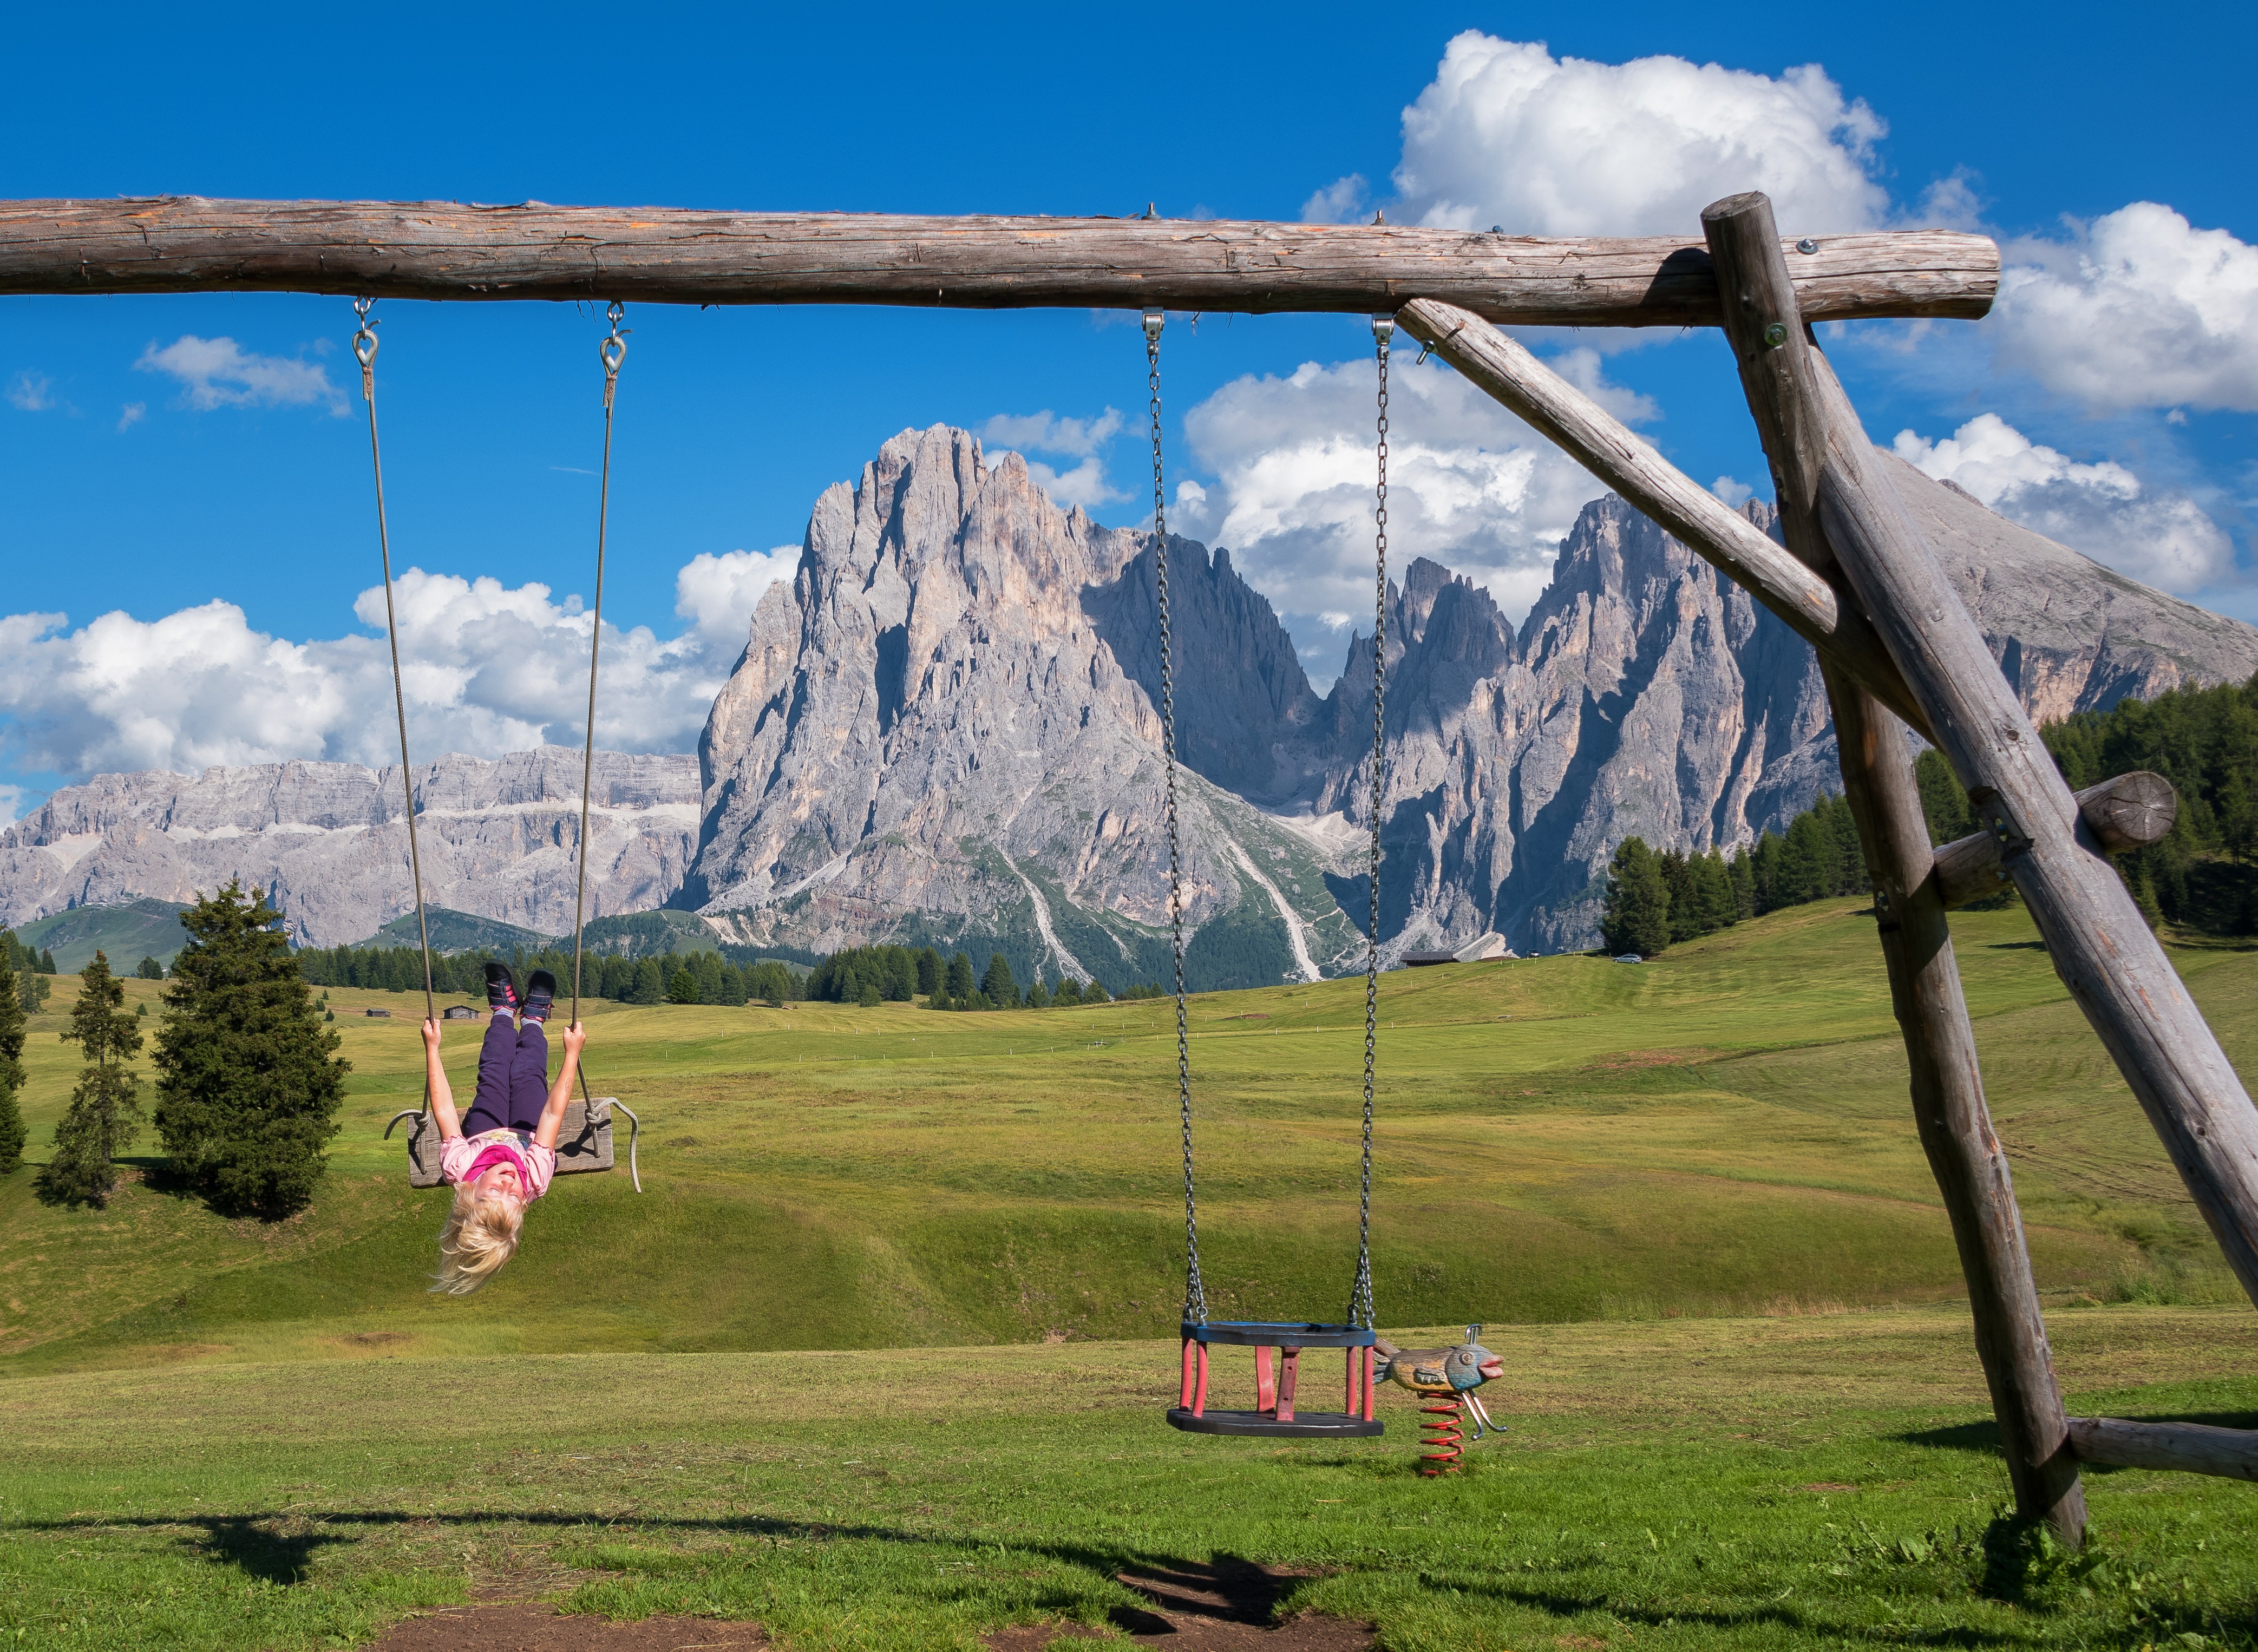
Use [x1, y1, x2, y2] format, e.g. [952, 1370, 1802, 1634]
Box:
[1372, 29, 1888, 237]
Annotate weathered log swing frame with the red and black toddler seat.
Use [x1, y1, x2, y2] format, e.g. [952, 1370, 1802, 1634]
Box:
[0, 194, 2258, 1546]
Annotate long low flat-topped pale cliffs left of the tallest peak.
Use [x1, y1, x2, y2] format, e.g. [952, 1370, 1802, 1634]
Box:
[0, 747, 698, 946]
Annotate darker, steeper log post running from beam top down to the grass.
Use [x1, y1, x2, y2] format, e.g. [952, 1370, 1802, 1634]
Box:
[1703, 194, 2086, 1548]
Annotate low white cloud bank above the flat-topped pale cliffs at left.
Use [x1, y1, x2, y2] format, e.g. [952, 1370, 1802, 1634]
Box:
[0, 548, 772, 776]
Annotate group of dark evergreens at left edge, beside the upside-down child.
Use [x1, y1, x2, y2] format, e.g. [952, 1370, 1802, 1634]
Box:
[0, 882, 350, 1218]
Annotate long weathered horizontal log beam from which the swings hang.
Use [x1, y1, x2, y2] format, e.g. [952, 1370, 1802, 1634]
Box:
[0, 196, 1998, 327]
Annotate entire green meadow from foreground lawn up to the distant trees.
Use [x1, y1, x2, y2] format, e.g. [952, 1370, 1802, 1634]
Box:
[0, 903, 2258, 1652]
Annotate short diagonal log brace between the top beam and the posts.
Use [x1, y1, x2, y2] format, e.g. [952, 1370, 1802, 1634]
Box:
[1396, 298, 1926, 731]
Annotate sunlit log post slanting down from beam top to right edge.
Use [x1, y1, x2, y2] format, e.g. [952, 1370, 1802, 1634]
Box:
[1703, 196, 2258, 1302]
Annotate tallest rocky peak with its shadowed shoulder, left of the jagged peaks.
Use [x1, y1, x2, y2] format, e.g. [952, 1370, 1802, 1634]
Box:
[684, 427, 1355, 988]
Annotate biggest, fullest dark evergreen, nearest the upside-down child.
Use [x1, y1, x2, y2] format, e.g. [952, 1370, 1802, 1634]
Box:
[154, 882, 350, 1218]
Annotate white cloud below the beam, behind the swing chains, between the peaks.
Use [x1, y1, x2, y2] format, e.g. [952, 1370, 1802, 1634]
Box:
[1170, 348, 1614, 686]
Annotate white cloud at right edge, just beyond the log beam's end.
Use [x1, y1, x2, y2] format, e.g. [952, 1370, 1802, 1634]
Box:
[1996, 201, 2258, 413]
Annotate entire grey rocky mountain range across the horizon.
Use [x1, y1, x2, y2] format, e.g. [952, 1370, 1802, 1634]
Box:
[0, 427, 2258, 991]
